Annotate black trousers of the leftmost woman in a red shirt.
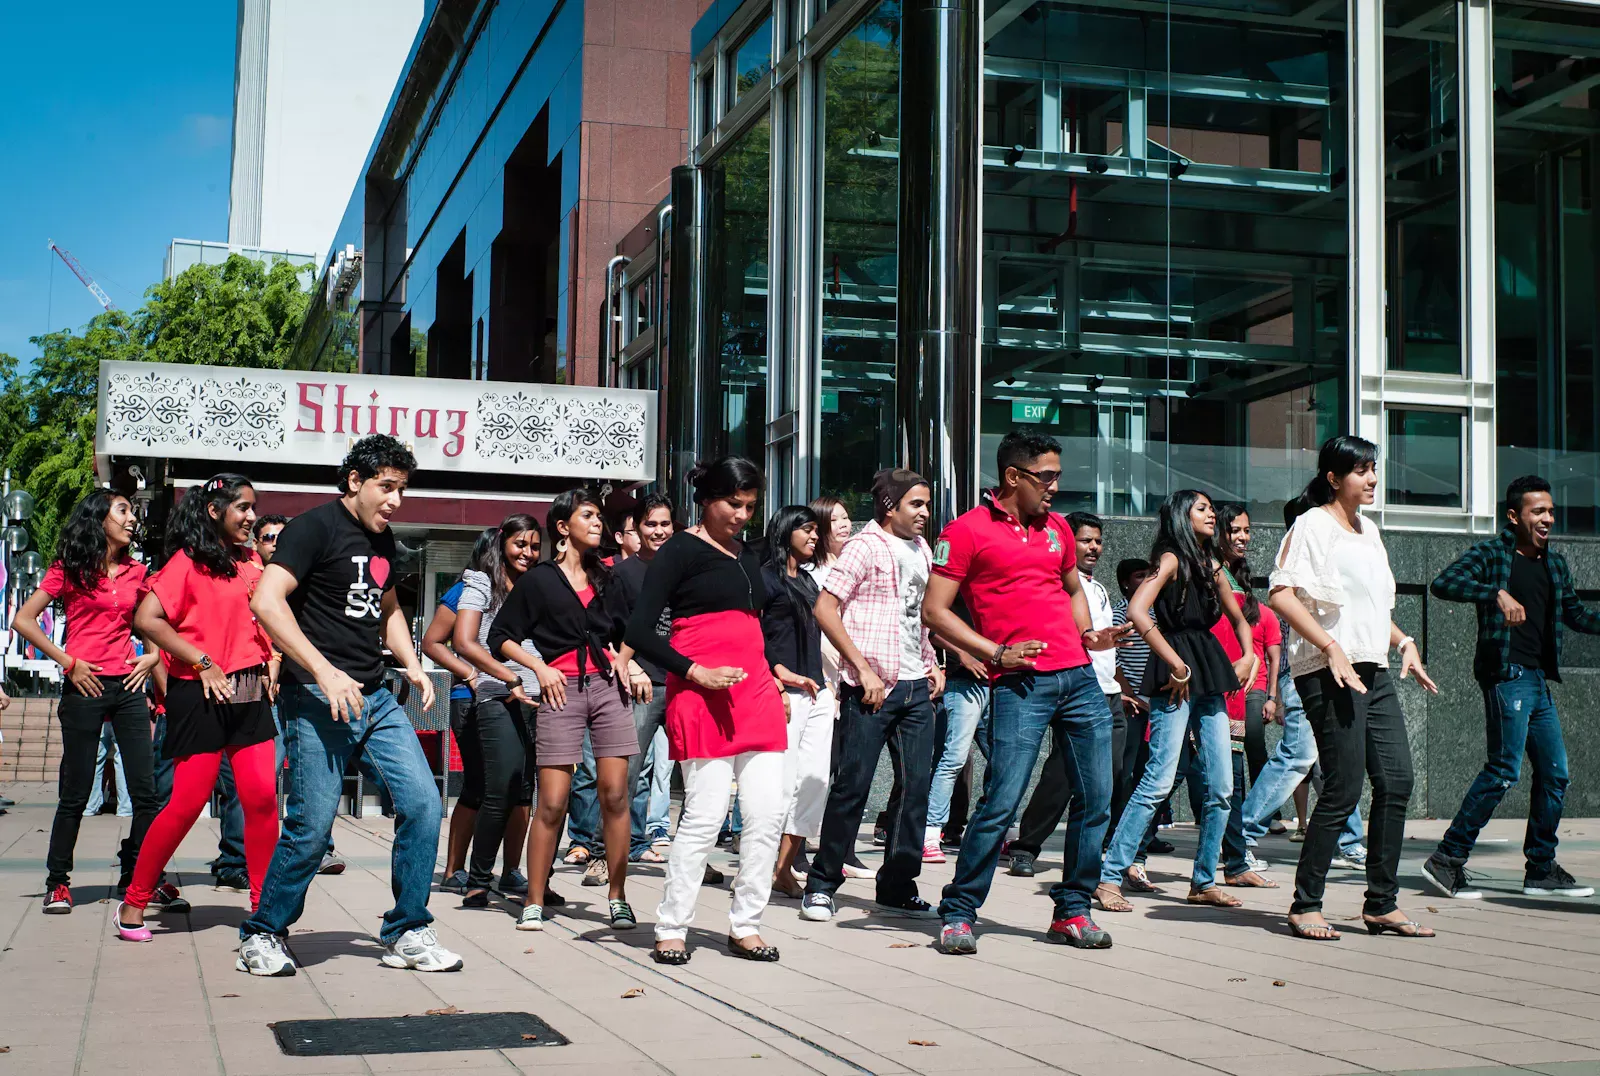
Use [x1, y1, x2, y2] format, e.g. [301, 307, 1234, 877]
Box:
[45, 676, 162, 889]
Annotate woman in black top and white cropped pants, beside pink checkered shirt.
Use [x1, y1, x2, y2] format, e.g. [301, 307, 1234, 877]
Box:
[762, 504, 835, 900]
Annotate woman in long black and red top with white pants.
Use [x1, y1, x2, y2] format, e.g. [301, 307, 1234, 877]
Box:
[624, 456, 789, 964]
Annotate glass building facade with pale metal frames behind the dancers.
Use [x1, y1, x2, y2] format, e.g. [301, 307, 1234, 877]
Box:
[681, 0, 1600, 533]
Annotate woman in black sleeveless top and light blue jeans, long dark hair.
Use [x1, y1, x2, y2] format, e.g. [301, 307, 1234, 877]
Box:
[1094, 490, 1254, 911]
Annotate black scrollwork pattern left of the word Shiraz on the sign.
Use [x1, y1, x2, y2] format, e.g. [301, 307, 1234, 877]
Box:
[106, 370, 288, 452]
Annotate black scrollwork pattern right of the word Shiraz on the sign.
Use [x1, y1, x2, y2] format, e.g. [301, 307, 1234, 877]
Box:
[475, 392, 646, 474]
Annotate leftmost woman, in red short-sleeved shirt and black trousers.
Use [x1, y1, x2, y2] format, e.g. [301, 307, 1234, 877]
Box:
[11, 490, 168, 914]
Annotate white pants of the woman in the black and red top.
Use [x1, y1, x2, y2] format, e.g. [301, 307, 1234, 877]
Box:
[656, 751, 789, 942]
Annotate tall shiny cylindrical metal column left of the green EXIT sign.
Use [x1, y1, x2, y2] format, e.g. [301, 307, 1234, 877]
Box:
[896, 0, 982, 527]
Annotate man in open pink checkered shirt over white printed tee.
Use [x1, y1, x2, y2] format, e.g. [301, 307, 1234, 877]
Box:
[800, 468, 944, 922]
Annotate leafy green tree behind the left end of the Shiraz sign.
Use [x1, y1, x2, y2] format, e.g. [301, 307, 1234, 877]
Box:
[0, 255, 310, 557]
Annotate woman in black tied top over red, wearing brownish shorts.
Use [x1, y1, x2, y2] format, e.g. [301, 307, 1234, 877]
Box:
[488, 488, 648, 930]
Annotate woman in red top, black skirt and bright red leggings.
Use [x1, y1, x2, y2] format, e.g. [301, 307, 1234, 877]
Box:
[117, 474, 278, 942]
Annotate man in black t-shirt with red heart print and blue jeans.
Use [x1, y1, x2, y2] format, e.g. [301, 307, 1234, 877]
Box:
[238, 434, 462, 975]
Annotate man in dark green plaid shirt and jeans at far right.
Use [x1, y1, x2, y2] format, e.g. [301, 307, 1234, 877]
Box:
[1422, 476, 1600, 900]
